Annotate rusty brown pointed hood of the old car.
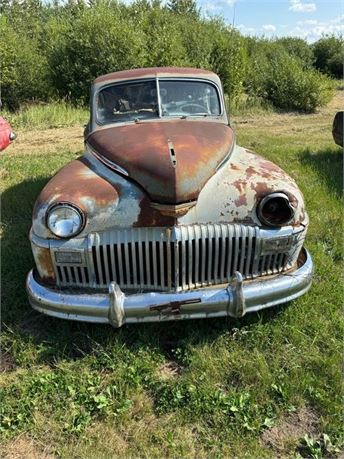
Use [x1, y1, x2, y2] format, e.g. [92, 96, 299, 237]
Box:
[87, 119, 234, 204]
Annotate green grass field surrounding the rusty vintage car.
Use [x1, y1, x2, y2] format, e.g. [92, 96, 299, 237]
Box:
[0, 91, 343, 459]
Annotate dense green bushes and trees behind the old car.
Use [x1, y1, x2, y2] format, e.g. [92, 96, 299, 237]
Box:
[0, 0, 343, 112]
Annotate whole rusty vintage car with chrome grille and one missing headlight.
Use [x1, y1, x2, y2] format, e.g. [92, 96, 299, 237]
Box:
[27, 67, 312, 327]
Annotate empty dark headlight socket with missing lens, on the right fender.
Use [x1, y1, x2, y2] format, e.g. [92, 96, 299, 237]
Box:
[257, 193, 295, 226]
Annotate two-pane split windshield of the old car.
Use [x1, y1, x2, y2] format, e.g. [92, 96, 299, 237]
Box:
[96, 80, 221, 124]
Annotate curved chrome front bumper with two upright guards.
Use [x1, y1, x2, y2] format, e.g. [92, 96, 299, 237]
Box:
[26, 249, 313, 327]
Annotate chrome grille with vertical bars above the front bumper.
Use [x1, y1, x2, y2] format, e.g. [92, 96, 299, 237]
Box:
[51, 224, 304, 291]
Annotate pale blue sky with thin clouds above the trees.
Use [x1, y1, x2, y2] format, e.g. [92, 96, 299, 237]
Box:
[197, 0, 344, 43]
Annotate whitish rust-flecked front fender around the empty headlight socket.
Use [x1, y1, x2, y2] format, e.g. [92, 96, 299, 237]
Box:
[180, 146, 307, 226]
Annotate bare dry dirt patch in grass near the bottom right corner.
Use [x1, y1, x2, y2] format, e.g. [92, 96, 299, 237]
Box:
[261, 408, 319, 457]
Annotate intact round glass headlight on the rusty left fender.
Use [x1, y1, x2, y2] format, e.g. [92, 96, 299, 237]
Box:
[47, 204, 85, 238]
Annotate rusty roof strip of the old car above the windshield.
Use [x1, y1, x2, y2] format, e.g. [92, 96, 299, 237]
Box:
[93, 67, 220, 86]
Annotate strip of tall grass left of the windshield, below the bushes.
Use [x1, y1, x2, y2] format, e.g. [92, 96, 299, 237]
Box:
[1, 102, 88, 129]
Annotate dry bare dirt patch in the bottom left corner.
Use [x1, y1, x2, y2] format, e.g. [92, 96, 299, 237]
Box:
[0, 435, 56, 459]
